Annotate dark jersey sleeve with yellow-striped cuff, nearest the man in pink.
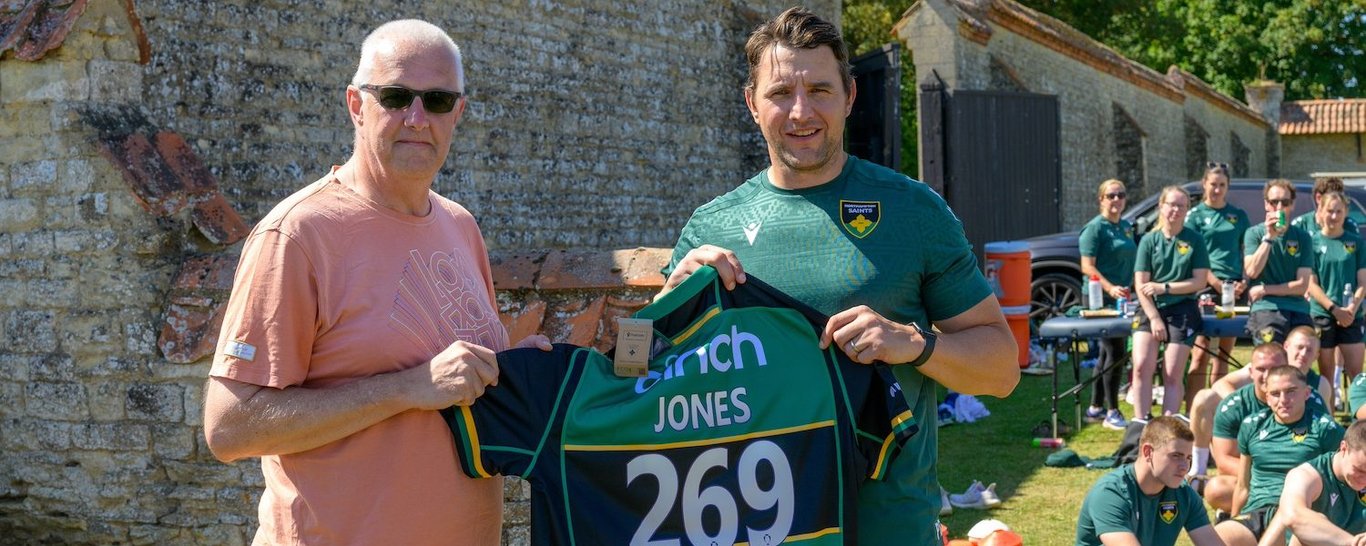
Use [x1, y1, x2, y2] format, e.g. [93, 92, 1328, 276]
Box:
[441, 344, 587, 478]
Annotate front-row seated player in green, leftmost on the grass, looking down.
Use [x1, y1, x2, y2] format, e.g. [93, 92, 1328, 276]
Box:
[1076, 415, 1224, 546]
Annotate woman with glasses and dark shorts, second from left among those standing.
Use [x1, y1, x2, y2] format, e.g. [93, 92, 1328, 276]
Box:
[1132, 186, 1209, 415]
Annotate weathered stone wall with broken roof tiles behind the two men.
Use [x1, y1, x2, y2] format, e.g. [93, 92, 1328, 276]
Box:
[0, 0, 839, 545]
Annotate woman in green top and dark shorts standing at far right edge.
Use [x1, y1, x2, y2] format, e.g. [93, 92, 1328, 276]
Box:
[1309, 191, 1366, 395]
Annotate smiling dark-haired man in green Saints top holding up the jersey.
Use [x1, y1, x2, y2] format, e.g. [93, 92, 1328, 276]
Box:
[664, 8, 1019, 546]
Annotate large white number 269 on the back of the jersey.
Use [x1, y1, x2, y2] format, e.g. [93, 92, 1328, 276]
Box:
[626, 440, 795, 546]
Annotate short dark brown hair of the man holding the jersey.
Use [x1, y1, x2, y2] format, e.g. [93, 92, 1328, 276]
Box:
[744, 7, 854, 93]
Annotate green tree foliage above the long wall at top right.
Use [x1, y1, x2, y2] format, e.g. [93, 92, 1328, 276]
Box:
[1019, 0, 1366, 100]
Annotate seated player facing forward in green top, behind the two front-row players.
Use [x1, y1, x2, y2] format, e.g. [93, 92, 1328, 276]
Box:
[1214, 366, 1343, 546]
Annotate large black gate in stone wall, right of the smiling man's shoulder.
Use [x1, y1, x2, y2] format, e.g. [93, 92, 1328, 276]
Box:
[945, 90, 1061, 257]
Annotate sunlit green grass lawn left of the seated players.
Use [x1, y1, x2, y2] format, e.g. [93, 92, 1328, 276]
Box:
[938, 344, 1251, 546]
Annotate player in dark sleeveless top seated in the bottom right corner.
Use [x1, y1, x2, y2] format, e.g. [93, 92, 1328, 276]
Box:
[1262, 420, 1366, 546]
